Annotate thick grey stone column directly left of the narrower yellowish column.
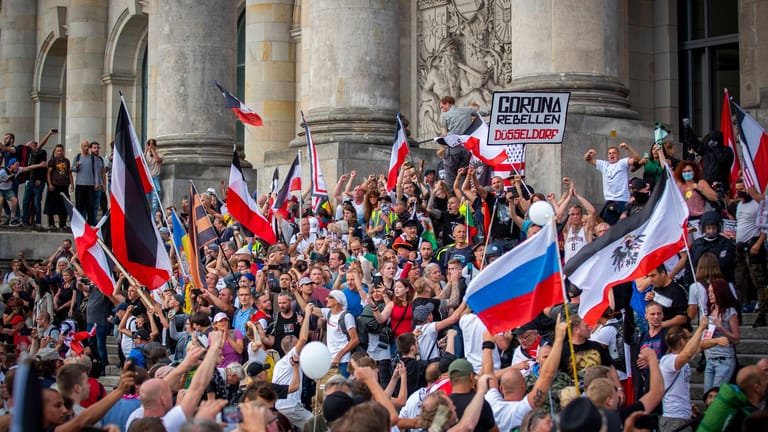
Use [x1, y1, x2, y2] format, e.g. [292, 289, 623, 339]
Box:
[148, 0, 237, 166]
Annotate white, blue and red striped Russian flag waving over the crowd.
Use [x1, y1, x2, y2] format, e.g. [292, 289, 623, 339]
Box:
[465, 219, 563, 334]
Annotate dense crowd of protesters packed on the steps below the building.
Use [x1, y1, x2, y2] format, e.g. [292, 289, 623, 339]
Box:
[0, 96, 768, 432]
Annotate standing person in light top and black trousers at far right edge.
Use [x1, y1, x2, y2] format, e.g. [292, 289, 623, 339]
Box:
[734, 179, 768, 326]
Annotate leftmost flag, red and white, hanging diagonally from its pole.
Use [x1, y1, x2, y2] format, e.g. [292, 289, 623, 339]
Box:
[64, 200, 115, 296]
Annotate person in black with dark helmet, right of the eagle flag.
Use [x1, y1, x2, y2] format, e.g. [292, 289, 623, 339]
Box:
[691, 211, 736, 283]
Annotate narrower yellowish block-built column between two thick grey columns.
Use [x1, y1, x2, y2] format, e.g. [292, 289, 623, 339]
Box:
[244, 0, 296, 164]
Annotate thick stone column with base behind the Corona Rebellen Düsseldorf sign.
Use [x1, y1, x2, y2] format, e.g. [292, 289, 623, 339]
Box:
[505, 0, 651, 203]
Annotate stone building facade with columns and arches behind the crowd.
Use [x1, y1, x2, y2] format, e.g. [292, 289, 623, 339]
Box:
[0, 0, 768, 206]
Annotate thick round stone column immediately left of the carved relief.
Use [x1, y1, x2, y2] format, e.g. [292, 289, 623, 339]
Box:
[294, 0, 403, 145]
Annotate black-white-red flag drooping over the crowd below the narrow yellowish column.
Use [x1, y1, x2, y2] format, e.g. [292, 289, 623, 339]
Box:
[227, 150, 277, 244]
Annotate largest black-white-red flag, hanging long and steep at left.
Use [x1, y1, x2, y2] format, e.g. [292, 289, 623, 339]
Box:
[110, 98, 171, 289]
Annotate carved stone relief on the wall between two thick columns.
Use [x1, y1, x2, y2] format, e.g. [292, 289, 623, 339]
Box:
[417, 0, 512, 139]
